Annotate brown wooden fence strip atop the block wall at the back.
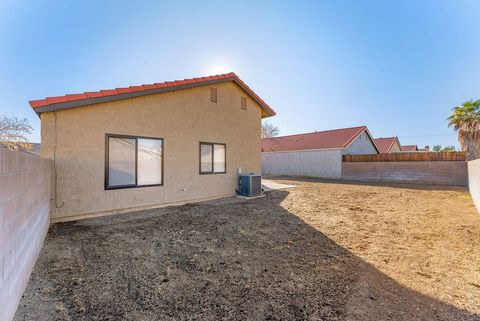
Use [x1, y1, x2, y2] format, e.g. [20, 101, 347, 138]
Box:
[342, 152, 467, 162]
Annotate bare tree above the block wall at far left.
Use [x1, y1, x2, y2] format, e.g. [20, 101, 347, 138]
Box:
[0, 115, 33, 149]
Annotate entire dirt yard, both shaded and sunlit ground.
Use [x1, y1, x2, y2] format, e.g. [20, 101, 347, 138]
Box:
[15, 180, 480, 320]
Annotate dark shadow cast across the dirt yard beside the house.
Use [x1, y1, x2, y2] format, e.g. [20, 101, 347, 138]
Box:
[15, 191, 480, 320]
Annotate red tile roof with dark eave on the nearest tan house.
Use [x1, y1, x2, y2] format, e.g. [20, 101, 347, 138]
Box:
[29, 72, 276, 117]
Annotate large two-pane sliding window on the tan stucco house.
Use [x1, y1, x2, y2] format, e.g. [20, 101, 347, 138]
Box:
[105, 134, 163, 189]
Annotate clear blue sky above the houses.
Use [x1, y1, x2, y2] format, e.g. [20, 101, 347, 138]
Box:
[0, 0, 480, 146]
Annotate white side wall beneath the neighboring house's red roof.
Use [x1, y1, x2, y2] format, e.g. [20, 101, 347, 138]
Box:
[262, 149, 342, 179]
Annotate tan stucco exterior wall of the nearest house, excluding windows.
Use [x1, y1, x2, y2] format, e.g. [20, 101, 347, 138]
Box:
[41, 82, 261, 221]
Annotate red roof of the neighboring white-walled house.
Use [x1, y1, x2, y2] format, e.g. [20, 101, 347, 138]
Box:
[262, 126, 376, 152]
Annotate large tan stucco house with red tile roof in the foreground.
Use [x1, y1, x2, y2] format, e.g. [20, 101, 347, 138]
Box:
[30, 73, 275, 221]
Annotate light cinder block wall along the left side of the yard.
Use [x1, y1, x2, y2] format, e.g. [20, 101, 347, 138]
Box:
[0, 147, 52, 321]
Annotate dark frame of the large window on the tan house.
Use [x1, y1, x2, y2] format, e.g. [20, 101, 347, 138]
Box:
[104, 134, 165, 190]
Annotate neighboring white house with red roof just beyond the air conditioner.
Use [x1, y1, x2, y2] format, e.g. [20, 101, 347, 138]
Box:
[262, 126, 379, 179]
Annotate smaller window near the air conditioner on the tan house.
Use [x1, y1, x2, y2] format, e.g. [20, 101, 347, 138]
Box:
[200, 143, 227, 174]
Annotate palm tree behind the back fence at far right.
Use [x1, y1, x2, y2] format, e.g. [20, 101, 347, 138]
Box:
[447, 99, 480, 159]
